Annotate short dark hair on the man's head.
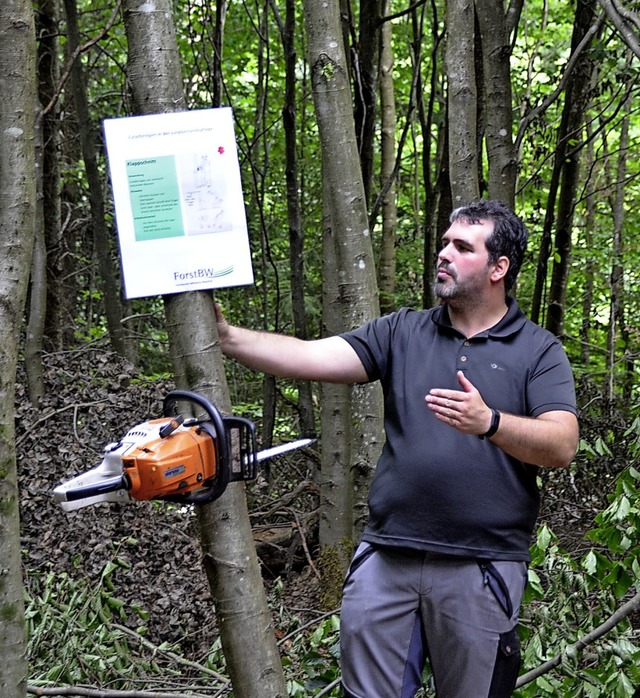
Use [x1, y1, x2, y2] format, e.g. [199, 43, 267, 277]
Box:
[449, 199, 528, 291]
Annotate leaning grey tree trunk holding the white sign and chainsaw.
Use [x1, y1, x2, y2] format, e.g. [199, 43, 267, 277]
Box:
[124, 0, 286, 698]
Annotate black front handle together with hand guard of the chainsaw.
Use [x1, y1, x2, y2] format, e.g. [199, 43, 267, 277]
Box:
[163, 390, 257, 504]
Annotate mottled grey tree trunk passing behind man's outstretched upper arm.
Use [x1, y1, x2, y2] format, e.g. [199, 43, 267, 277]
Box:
[304, 0, 382, 556]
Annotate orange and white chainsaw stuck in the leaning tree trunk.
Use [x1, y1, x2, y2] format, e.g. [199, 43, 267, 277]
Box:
[53, 390, 314, 511]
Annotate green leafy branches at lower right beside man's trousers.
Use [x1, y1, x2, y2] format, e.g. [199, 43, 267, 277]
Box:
[516, 406, 640, 698]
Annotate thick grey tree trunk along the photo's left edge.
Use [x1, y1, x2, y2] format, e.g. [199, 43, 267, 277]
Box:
[0, 0, 37, 698]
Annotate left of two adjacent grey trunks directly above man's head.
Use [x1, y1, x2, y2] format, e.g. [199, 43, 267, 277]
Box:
[446, 0, 480, 206]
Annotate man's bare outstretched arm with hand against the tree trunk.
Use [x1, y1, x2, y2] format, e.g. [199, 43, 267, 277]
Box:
[214, 303, 367, 383]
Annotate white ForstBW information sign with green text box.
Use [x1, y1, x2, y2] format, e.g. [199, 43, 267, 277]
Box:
[104, 107, 253, 298]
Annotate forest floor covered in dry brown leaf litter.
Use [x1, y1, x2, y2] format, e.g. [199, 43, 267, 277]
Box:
[16, 349, 603, 684]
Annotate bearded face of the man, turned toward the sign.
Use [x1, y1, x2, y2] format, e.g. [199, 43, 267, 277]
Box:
[434, 221, 493, 305]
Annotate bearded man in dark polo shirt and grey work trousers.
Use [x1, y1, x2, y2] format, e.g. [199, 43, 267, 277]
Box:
[216, 201, 578, 698]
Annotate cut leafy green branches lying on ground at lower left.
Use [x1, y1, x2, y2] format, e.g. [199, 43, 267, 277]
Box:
[25, 550, 226, 691]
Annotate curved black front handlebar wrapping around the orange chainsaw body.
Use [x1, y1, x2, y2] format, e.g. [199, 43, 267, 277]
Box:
[163, 390, 231, 504]
